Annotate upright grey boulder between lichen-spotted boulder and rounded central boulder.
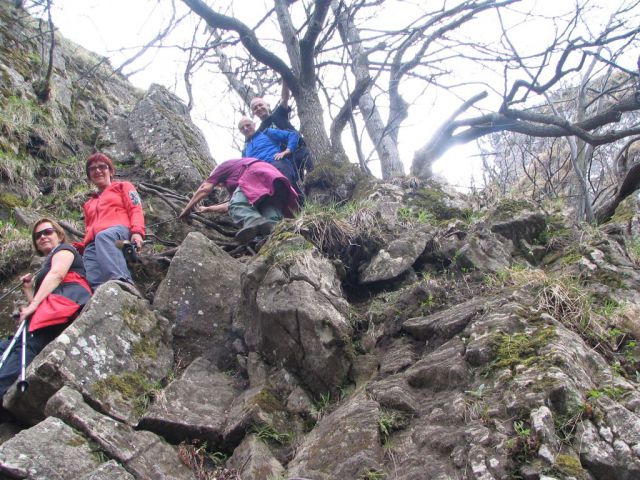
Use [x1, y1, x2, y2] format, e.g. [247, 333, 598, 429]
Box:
[153, 232, 245, 371]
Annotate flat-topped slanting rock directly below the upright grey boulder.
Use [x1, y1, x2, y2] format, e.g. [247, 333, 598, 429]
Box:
[140, 358, 240, 447]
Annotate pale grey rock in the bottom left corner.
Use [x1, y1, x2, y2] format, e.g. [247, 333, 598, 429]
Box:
[0, 417, 100, 480]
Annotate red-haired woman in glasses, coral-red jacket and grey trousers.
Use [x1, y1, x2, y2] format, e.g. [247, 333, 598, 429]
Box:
[82, 152, 144, 290]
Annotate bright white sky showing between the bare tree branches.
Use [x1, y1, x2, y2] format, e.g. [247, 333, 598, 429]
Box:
[43, 0, 636, 190]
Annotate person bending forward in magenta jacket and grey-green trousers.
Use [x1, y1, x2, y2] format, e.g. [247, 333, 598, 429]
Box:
[180, 158, 298, 243]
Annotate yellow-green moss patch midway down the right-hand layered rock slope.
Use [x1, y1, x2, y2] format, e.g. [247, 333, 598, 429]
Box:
[490, 327, 556, 370]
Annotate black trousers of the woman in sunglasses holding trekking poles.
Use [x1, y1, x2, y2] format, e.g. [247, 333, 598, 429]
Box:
[0, 323, 68, 398]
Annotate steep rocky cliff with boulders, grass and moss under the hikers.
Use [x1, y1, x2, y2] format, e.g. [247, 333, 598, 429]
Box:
[0, 3, 640, 480]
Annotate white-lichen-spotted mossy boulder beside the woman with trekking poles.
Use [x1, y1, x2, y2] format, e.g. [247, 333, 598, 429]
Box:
[3, 282, 173, 425]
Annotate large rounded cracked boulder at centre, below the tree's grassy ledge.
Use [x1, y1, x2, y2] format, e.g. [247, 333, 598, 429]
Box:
[239, 236, 353, 396]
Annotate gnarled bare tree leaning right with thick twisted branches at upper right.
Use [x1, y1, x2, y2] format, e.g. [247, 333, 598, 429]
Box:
[412, 0, 640, 187]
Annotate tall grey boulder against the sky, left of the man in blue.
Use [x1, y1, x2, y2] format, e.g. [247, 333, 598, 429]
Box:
[129, 85, 215, 190]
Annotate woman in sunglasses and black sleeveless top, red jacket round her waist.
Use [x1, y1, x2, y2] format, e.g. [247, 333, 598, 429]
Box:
[0, 218, 92, 397]
